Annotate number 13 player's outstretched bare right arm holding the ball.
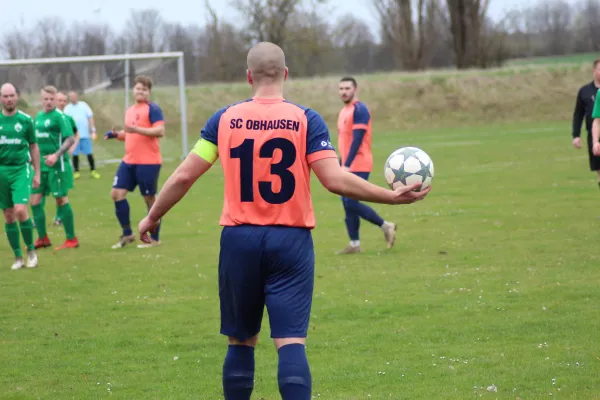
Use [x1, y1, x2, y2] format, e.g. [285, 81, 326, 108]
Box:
[310, 158, 431, 204]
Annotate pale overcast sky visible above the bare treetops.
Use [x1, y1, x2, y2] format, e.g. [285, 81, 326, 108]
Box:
[0, 0, 537, 37]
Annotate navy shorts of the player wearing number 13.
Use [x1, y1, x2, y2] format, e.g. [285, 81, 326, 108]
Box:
[219, 225, 315, 341]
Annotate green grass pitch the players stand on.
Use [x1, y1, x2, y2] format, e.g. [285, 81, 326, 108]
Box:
[0, 115, 600, 400]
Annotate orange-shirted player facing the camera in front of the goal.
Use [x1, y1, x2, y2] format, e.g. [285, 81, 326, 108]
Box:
[104, 76, 165, 249]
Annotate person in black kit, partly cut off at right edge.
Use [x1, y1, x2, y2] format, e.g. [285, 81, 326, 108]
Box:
[572, 59, 600, 186]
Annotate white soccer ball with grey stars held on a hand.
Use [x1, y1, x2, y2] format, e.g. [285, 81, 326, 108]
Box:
[384, 147, 433, 192]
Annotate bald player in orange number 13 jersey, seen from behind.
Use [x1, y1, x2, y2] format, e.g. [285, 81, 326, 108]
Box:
[138, 42, 429, 400]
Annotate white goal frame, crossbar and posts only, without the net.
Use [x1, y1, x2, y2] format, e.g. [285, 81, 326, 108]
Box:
[0, 51, 189, 159]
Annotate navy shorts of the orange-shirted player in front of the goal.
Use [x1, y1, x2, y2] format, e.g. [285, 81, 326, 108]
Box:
[113, 162, 160, 196]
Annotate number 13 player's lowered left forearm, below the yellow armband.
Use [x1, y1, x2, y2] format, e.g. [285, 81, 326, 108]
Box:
[138, 153, 212, 242]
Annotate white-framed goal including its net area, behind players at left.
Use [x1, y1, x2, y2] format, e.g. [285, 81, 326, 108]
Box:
[0, 52, 188, 164]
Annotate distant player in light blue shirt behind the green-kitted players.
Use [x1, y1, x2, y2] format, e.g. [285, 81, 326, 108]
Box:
[64, 91, 100, 179]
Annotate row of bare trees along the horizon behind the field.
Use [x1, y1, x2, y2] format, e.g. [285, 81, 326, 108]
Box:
[0, 0, 600, 83]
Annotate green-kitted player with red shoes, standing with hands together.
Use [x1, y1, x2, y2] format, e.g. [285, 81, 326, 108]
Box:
[31, 86, 79, 250]
